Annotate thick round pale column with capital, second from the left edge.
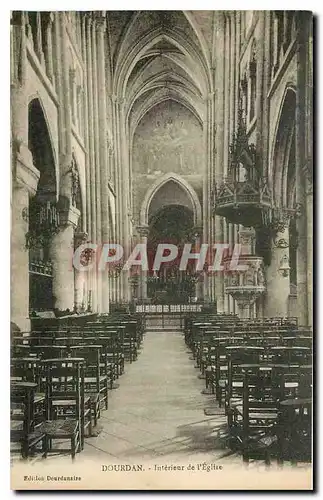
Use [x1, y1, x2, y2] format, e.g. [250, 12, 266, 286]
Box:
[50, 206, 80, 311]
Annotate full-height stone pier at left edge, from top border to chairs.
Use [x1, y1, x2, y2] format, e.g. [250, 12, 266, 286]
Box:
[10, 12, 36, 331]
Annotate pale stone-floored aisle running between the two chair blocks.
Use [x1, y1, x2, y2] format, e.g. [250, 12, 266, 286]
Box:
[81, 332, 232, 463]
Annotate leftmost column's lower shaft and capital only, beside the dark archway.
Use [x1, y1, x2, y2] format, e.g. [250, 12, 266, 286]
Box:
[11, 143, 40, 331]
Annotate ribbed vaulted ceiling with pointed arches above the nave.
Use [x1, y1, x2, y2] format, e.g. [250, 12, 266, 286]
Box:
[108, 11, 216, 138]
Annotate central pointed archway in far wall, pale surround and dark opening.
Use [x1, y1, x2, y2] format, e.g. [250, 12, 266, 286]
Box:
[140, 173, 202, 303]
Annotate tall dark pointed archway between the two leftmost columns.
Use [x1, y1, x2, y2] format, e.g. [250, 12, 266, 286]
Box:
[26, 99, 59, 312]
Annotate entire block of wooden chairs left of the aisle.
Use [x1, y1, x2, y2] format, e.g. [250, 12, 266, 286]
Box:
[11, 315, 144, 458]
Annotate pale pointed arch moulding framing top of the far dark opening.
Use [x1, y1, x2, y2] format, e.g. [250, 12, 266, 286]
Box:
[140, 172, 202, 226]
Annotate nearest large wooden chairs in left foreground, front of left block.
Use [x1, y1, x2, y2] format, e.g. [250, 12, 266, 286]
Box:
[11, 358, 92, 458]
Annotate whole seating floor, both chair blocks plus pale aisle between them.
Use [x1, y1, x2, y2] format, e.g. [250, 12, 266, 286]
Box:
[11, 312, 312, 466]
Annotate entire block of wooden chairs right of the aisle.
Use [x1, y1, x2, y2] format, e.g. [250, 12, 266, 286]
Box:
[185, 315, 312, 463]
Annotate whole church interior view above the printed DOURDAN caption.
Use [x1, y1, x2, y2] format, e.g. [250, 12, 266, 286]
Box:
[10, 10, 313, 467]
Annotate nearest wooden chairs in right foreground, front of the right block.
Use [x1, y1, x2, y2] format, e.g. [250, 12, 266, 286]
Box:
[226, 365, 312, 464]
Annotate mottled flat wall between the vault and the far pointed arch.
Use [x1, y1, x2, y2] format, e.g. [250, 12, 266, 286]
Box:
[132, 101, 205, 222]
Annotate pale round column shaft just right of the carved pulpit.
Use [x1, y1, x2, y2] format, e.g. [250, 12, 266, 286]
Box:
[265, 220, 290, 317]
